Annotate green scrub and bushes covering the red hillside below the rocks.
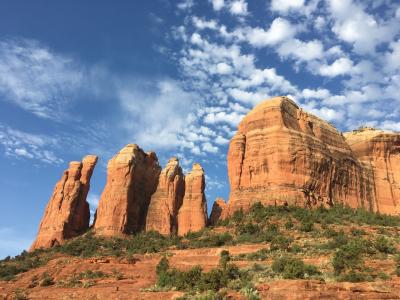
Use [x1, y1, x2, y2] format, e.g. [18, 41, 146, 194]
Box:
[0, 203, 400, 294]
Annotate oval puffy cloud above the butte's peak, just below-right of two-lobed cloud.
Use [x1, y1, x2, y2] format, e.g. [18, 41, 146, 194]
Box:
[277, 39, 324, 61]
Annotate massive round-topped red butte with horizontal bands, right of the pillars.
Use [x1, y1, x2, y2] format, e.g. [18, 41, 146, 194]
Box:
[227, 97, 376, 213]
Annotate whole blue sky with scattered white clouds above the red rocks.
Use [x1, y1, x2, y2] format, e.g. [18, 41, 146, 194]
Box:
[0, 0, 400, 257]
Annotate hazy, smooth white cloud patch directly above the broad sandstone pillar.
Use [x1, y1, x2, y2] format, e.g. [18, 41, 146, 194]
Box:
[119, 79, 198, 150]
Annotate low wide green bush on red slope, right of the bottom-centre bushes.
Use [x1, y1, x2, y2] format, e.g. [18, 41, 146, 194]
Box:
[272, 256, 321, 279]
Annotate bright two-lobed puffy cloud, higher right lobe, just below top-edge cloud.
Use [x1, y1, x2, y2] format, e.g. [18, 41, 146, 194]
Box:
[245, 17, 297, 47]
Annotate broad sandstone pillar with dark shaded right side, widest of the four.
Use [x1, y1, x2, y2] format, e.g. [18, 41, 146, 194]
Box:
[94, 144, 161, 236]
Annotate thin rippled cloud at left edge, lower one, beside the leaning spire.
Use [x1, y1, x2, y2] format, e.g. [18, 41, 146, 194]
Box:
[0, 124, 63, 164]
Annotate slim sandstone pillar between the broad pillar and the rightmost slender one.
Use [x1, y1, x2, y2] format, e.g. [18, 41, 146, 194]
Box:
[146, 157, 185, 235]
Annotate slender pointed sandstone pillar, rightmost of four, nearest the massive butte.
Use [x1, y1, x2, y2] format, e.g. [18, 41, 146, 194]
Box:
[178, 164, 207, 236]
